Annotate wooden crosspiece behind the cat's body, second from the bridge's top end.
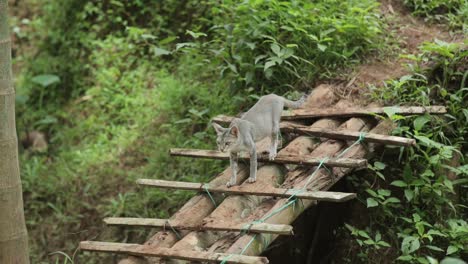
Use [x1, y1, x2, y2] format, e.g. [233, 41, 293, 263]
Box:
[213, 115, 416, 146]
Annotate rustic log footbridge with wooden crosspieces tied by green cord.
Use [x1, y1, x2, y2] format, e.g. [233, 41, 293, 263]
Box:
[80, 86, 446, 264]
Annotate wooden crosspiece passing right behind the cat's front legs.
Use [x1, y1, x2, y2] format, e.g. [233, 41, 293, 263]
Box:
[170, 148, 367, 168]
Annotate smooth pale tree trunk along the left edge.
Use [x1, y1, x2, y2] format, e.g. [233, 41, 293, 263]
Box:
[0, 0, 29, 264]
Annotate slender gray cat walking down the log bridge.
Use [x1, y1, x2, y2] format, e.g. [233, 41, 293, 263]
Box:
[213, 94, 306, 187]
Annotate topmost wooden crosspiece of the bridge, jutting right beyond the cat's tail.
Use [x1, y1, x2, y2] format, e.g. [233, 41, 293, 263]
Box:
[281, 106, 447, 120]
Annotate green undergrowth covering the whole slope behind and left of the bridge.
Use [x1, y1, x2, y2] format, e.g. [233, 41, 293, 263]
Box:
[10, 0, 384, 263]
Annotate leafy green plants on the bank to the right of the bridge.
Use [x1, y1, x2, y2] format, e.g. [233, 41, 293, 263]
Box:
[348, 41, 468, 263]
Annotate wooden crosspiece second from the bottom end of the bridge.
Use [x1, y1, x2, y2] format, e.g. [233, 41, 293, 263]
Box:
[104, 217, 293, 235]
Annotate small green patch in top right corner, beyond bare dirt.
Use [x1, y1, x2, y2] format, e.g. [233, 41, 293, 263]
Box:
[404, 0, 468, 33]
